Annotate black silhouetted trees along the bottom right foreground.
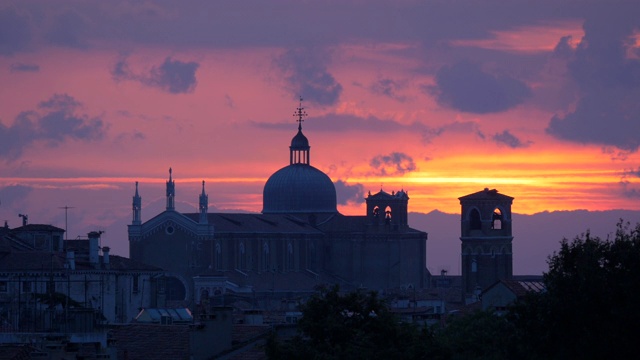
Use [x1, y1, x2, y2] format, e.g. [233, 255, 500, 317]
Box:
[267, 222, 640, 360]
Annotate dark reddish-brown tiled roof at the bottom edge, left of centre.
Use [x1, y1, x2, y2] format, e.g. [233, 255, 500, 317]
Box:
[109, 324, 190, 360]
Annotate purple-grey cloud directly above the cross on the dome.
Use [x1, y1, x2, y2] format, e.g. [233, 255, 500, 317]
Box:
[276, 48, 342, 106]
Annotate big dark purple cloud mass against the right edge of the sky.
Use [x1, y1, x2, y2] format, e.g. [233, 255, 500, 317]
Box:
[547, 11, 640, 151]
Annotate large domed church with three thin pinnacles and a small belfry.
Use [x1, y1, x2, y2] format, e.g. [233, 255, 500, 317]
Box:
[128, 104, 429, 306]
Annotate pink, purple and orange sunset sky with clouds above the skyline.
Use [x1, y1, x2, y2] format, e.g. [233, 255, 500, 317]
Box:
[0, 0, 640, 255]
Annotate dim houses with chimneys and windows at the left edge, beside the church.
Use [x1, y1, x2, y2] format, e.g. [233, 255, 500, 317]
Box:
[0, 225, 163, 332]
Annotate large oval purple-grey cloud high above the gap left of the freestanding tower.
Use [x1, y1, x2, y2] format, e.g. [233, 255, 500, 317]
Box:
[424, 62, 531, 114]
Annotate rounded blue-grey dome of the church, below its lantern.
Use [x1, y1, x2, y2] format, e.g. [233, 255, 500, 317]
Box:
[262, 164, 337, 214]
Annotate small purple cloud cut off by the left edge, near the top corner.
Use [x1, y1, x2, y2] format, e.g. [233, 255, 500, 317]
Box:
[0, 6, 31, 55]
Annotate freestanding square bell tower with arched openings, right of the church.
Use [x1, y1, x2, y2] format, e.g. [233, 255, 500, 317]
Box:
[459, 188, 513, 297]
